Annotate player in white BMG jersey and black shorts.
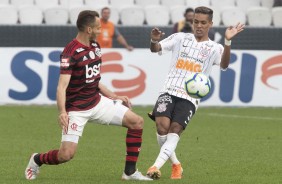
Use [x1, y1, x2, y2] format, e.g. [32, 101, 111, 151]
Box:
[147, 7, 244, 179]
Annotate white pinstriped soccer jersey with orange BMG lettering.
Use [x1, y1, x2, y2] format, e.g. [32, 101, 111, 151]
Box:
[159, 33, 223, 108]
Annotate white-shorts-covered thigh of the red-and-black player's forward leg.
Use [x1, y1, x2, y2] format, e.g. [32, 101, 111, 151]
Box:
[90, 96, 129, 126]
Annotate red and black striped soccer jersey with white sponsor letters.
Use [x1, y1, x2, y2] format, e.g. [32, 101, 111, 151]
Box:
[60, 39, 102, 112]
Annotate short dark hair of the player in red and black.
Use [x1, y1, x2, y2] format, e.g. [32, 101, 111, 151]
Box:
[76, 10, 99, 31]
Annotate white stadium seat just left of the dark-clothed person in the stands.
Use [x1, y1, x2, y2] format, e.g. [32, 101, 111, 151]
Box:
[144, 5, 170, 26]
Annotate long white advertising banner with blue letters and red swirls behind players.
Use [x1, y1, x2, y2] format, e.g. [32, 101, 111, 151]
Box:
[0, 48, 282, 107]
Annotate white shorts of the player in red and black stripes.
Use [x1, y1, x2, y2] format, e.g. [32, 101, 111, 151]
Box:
[62, 96, 128, 143]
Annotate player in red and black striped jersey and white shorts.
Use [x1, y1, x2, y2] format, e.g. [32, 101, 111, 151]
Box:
[25, 10, 151, 180]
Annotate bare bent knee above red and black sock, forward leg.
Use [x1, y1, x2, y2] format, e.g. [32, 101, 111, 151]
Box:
[122, 110, 144, 129]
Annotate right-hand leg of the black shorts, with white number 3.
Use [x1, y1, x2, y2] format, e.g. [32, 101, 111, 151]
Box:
[171, 98, 196, 129]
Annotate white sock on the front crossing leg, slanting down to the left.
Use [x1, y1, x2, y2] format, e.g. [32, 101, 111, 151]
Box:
[154, 133, 180, 169]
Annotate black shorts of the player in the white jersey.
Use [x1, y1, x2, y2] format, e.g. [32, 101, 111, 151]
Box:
[153, 93, 196, 129]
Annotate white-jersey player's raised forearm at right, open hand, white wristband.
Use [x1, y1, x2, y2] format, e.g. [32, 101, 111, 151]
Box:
[220, 23, 245, 69]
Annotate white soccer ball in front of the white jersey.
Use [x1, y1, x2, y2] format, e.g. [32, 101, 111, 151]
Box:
[184, 73, 211, 98]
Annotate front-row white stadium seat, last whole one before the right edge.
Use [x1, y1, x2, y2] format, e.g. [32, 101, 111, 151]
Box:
[247, 7, 272, 27]
